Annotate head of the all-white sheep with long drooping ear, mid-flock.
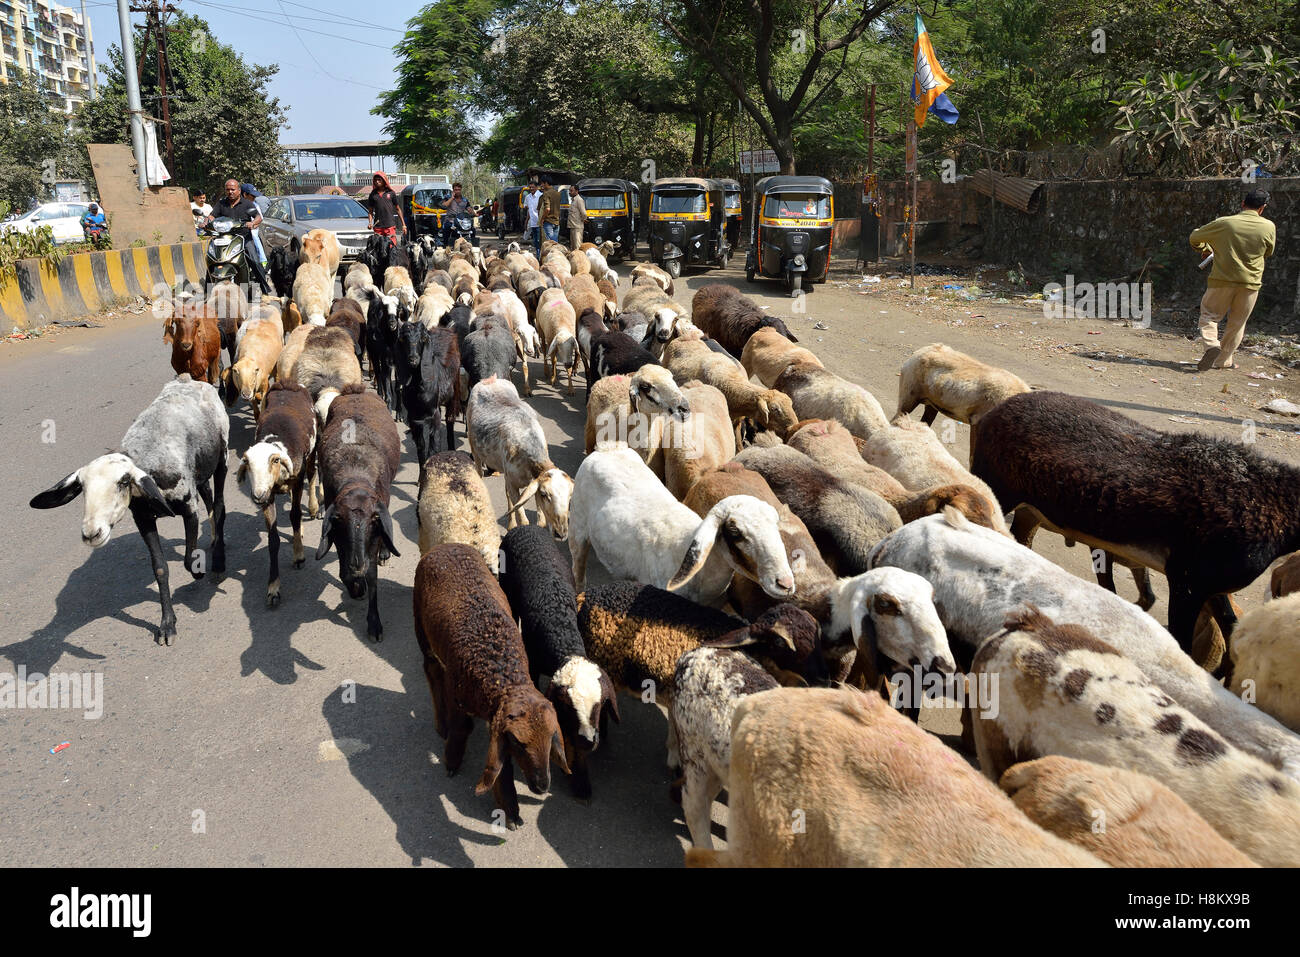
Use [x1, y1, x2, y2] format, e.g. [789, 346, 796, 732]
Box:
[668, 495, 794, 598]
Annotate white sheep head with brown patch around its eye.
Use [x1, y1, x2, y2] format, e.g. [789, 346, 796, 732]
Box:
[849, 567, 957, 675]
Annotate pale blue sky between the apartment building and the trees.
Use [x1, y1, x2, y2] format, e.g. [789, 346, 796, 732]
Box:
[81, 0, 429, 144]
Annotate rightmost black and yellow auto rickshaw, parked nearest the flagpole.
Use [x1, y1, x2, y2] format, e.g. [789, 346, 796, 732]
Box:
[745, 176, 835, 296]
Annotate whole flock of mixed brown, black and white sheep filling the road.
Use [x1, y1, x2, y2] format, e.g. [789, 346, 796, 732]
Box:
[31, 231, 1300, 866]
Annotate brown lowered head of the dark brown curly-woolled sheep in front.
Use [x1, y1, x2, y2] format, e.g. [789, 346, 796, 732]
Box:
[475, 684, 569, 806]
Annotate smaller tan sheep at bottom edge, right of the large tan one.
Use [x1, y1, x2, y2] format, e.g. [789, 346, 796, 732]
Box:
[998, 754, 1258, 867]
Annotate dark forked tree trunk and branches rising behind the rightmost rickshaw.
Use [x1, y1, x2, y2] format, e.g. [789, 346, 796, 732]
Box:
[660, 0, 898, 174]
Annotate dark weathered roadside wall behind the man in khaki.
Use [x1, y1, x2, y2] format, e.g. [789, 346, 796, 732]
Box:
[881, 177, 1300, 332]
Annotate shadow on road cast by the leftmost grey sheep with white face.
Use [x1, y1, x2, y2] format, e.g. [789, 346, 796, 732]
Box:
[9, 518, 229, 674]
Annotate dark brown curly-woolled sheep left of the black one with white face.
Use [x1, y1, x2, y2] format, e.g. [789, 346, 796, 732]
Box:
[413, 544, 569, 830]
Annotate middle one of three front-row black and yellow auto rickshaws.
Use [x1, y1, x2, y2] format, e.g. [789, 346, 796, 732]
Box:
[650, 177, 731, 278]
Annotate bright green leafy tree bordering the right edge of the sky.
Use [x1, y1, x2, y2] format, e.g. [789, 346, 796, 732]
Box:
[371, 0, 501, 166]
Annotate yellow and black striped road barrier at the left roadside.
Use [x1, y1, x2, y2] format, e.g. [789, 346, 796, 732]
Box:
[0, 242, 205, 334]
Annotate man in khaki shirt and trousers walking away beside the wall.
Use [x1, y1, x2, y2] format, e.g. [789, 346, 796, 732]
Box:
[1188, 190, 1277, 372]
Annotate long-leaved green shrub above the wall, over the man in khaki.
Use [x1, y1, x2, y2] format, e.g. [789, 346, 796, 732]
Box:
[1114, 40, 1300, 174]
